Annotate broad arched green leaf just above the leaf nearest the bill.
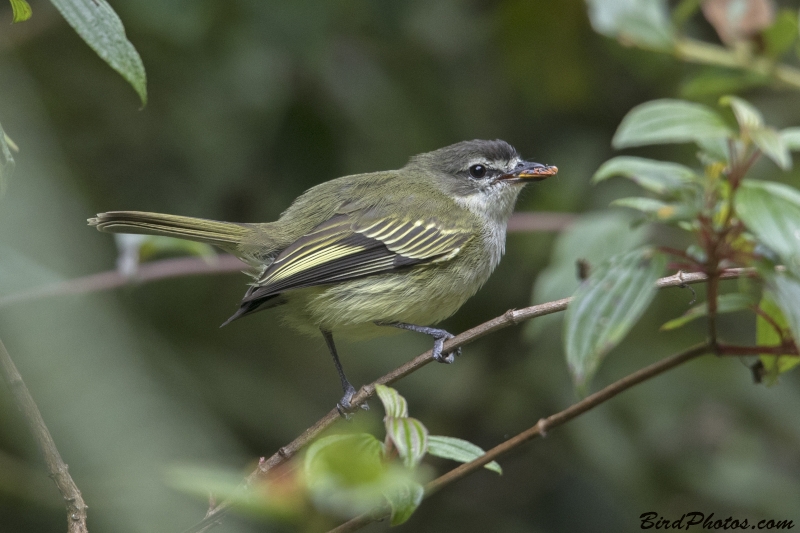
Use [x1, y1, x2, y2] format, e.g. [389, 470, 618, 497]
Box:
[611, 99, 733, 148]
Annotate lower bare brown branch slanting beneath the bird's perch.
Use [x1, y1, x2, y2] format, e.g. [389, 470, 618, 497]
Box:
[328, 343, 710, 533]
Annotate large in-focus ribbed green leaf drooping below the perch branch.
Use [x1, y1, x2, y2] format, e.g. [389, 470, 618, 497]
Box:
[564, 248, 666, 388]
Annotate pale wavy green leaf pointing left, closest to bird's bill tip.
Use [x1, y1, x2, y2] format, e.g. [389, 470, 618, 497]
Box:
[592, 156, 698, 195]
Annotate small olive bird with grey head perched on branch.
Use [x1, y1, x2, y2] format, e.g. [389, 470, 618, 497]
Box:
[89, 140, 558, 412]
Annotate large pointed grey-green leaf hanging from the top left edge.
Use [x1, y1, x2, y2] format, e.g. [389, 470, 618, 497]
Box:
[50, 0, 147, 105]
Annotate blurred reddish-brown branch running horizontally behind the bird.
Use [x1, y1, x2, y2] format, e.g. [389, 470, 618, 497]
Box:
[0, 212, 577, 307]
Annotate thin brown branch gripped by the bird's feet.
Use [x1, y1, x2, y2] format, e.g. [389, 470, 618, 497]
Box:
[184, 268, 755, 533]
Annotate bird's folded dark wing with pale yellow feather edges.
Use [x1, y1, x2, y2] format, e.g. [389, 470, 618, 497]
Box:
[242, 213, 472, 304]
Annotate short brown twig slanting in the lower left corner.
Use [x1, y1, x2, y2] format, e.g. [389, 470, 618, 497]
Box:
[0, 340, 88, 533]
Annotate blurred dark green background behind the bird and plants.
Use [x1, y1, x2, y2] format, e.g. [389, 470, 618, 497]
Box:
[0, 0, 800, 533]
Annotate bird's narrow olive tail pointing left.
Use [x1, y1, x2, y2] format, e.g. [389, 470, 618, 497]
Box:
[89, 211, 253, 251]
